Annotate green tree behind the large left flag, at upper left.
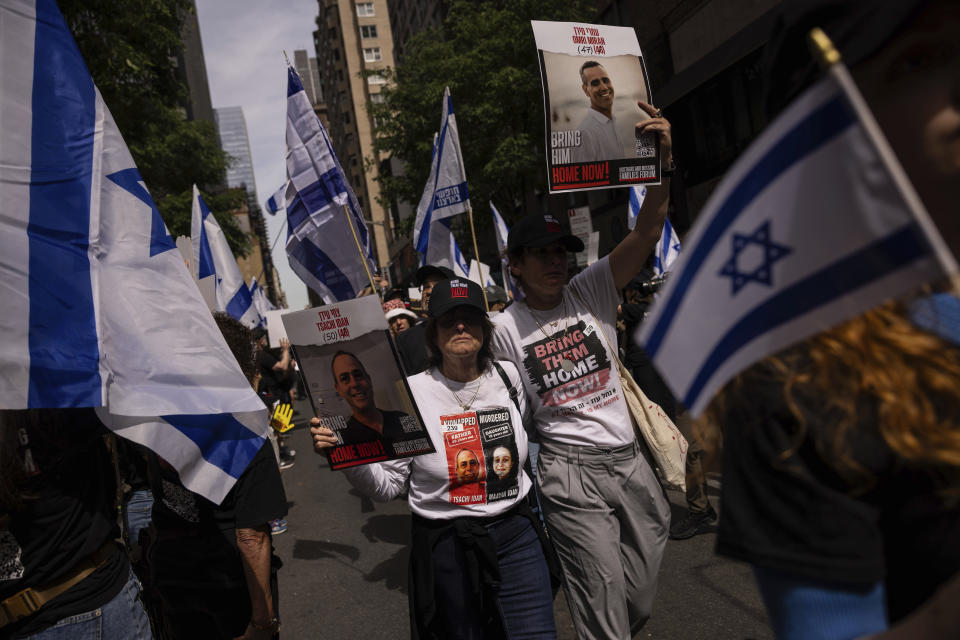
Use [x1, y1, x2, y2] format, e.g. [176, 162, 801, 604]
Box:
[59, 0, 250, 256]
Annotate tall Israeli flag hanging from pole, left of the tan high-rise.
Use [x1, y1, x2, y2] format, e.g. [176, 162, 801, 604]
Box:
[286, 67, 376, 303]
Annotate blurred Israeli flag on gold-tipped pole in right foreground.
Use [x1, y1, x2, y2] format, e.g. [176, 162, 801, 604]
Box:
[639, 65, 957, 415]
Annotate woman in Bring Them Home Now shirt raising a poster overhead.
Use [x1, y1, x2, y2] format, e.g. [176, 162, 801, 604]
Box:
[493, 104, 671, 639]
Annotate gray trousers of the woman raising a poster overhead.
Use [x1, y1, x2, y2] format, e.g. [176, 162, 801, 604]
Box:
[537, 441, 670, 640]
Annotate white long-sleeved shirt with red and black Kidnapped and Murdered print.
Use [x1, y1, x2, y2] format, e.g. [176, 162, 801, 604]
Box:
[344, 362, 531, 520]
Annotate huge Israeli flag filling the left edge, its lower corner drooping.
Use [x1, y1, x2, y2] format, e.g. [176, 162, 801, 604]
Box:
[0, 0, 269, 502]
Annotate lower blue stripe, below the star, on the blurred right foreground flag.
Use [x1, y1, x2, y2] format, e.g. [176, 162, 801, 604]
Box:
[683, 224, 930, 407]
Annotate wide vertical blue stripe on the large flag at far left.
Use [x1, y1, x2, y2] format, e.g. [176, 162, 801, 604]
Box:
[24, 0, 103, 407]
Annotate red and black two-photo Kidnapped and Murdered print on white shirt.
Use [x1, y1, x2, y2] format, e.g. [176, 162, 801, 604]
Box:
[440, 407, 520, 504]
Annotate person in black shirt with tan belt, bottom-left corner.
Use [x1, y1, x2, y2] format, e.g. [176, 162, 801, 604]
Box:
[0, 409, 151, 639]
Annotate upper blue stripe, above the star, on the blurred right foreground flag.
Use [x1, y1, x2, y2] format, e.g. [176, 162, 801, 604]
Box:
[644, 96, 856, 359]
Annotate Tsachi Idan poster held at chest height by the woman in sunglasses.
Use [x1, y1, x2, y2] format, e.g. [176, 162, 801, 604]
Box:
[282, 296, 435, 470]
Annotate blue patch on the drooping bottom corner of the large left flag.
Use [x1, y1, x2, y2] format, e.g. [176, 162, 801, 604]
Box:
[161, 413, 265, 478]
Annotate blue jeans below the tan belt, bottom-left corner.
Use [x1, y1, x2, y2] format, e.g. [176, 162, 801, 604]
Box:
[26, 573, 153, 640]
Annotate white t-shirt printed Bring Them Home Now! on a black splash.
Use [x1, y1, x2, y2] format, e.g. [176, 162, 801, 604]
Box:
[492, 256, 634, 447]
